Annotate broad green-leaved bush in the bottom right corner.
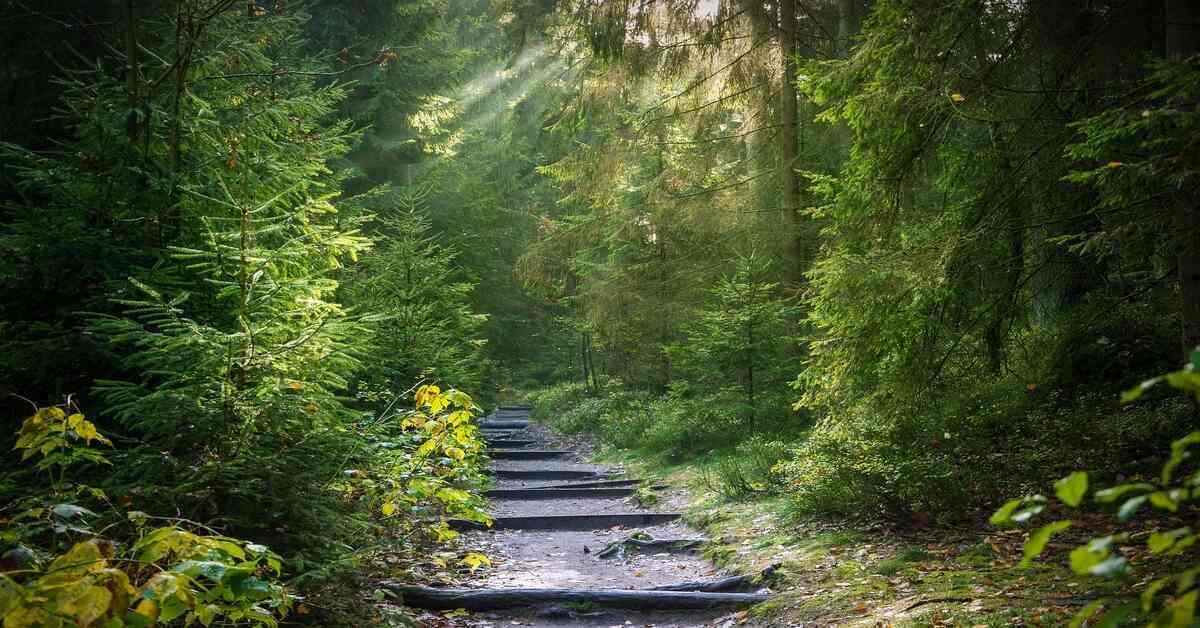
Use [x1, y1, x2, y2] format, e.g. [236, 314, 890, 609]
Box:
[991, 349, 1200, 628]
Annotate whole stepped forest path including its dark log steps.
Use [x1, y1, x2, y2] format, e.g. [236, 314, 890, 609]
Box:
[404, 407, 766, 628]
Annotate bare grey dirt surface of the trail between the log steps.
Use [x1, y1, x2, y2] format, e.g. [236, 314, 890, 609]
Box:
[408, 408, 766, 628]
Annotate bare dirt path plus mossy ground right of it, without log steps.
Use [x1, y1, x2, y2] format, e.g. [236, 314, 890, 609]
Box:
[393, 410, 1141, 628]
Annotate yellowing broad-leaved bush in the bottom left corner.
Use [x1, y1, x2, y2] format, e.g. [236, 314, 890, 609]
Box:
[0, 403, 294, 628]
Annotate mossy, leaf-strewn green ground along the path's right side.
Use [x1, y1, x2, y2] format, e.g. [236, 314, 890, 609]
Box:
[601, 450, 1137, 627]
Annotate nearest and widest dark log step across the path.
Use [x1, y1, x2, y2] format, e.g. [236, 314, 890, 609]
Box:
[380, 582, 770, 611]
